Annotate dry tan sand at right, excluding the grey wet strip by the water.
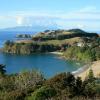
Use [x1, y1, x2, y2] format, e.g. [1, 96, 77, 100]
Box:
[75, 60, 100, 80]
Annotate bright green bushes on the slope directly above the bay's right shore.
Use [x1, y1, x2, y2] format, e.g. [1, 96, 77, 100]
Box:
[64, 45, 100, 62]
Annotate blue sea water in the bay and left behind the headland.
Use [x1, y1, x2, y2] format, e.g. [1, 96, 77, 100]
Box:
[0, 33, 80, 77]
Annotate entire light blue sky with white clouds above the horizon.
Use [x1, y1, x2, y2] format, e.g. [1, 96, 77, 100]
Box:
[0, 0, 100, 31]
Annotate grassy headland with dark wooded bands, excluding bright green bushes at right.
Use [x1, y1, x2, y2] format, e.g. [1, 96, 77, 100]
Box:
[3, 29, 100, 58]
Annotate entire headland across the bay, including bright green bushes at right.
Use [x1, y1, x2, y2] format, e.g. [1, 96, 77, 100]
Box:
[3, 29, 100, 62]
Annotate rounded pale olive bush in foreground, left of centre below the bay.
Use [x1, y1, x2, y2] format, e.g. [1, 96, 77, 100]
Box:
[15, 71, 44, 91]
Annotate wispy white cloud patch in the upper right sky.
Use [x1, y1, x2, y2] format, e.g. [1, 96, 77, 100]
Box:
[60, 6, 100, 21]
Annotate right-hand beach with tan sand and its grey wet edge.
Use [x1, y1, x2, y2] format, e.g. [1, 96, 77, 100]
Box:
[73, 60, 100, 80]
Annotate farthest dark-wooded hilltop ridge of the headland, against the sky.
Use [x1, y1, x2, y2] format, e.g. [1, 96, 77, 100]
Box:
[33, 29, 99, 41]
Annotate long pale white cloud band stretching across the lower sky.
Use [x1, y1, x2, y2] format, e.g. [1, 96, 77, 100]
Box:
[0, 6, 100, 30]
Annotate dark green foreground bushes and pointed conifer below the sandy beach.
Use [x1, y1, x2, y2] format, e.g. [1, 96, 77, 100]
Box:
[28, 70, 100, 100]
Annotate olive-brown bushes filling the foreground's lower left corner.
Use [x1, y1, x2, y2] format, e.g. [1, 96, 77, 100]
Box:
[0, 67, 45, 100]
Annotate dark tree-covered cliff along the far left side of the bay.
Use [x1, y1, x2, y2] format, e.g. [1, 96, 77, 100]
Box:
[3, 43, 60, 54]
